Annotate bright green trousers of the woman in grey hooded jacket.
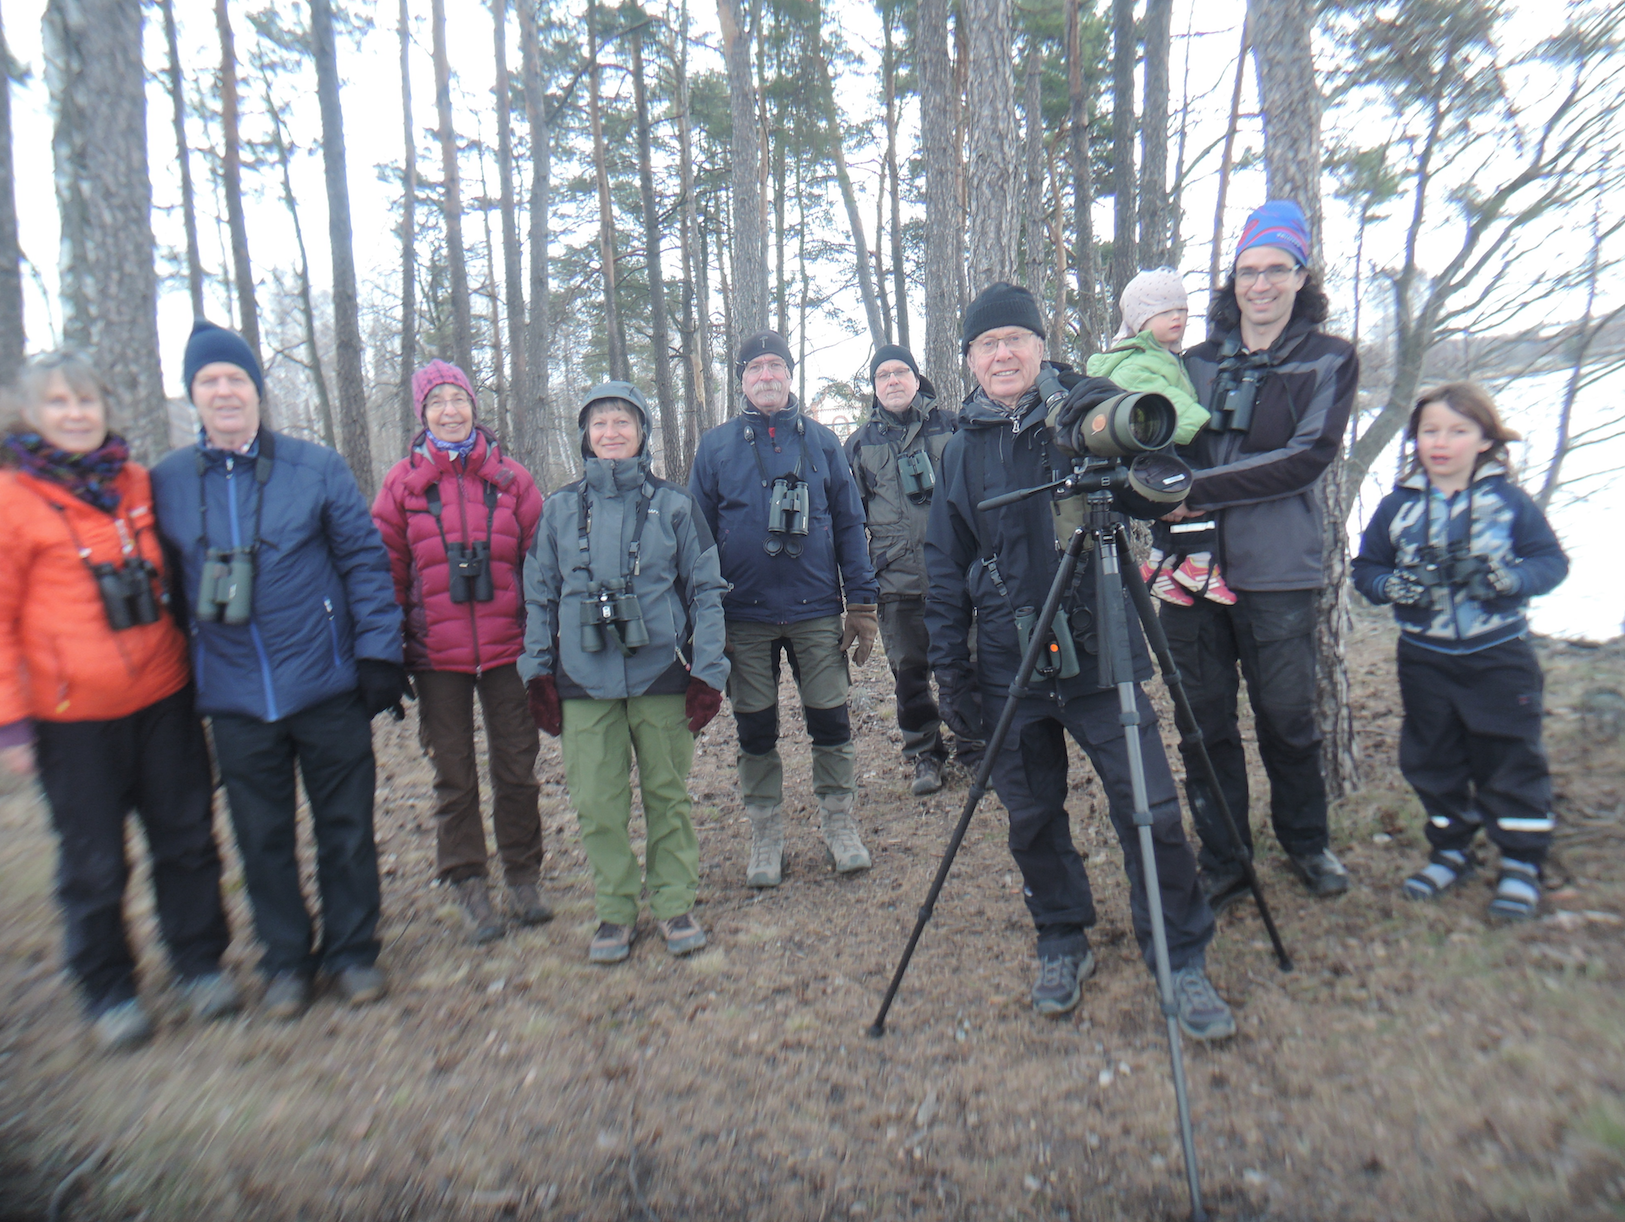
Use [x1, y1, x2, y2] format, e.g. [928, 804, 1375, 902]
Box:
[564, 696, 700, 925]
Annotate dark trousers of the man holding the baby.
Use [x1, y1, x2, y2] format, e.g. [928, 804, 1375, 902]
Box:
[1159, 590, 1328, 869]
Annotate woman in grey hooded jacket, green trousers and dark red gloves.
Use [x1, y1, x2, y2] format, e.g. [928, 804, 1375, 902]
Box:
[518, 382, 728, 964]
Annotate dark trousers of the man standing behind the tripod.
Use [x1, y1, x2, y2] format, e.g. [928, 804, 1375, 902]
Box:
[983, 687, 1214, 970]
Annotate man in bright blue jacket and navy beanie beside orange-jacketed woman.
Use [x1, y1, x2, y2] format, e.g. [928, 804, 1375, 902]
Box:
[153, 320, 406, 1019]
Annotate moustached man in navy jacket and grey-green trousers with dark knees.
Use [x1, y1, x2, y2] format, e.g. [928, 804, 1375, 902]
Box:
[689, 332, 879, 887]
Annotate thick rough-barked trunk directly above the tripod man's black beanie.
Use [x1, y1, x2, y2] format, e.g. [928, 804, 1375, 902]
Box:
[962, 0, 1017, 293]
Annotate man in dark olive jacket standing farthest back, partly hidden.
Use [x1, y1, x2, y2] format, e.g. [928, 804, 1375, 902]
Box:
[847, 345, 982, 796]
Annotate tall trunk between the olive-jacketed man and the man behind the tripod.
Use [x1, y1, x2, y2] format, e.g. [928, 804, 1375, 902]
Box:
[917, 0, 965, 408]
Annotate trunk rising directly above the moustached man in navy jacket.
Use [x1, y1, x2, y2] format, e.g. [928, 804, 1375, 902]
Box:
[717, 0, 767, 336]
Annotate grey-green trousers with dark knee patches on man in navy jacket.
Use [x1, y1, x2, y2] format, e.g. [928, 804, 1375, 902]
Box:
[728, 616, 856, 806]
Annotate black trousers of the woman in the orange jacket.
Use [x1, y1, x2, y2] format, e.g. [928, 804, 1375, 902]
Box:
[34, 687, 231, 1017]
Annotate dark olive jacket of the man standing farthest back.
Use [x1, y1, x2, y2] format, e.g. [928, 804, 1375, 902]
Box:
[847, 391, 959, 601]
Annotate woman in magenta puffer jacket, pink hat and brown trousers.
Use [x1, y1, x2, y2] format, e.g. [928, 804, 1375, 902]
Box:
[372, 361, 553, 943]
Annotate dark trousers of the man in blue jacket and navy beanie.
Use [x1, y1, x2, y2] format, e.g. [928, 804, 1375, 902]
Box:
[213, 692, 379, 977]
